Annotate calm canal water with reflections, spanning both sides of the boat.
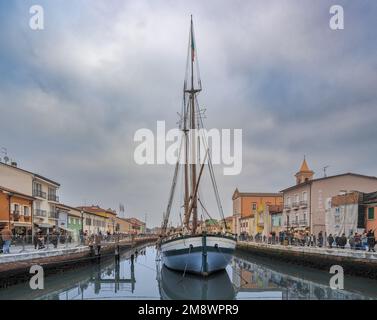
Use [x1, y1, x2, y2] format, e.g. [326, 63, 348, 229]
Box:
[0, 246, 377, 300]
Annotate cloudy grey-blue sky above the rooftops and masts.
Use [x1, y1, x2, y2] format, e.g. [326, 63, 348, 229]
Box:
[0, 0, 377, 225]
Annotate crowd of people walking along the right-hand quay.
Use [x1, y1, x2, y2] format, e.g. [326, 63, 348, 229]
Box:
[239, 230, 376, 252]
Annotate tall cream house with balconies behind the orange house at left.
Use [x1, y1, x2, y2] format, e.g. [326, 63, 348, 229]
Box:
[0, 162, 60, 233]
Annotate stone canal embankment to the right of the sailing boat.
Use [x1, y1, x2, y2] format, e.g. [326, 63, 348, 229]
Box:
[237, 241, 377, 279]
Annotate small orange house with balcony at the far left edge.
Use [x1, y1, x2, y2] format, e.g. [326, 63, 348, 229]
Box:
[0, 187, 35, 236]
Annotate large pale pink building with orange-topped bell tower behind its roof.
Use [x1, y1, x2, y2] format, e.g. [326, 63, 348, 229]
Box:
[281, 159, 377, 234]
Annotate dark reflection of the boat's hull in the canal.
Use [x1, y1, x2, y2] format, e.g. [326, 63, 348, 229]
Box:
[157, 266, 236, 300]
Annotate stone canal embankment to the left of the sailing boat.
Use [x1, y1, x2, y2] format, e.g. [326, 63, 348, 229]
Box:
[0, 237, 156, 288]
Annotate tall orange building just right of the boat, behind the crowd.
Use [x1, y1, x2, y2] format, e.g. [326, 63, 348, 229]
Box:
[232, 189, 283, 236]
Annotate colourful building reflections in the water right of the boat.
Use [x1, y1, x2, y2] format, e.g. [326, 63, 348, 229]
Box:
[232, 257, 367, 300]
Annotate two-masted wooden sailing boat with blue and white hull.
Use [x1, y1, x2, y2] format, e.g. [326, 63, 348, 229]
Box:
[159, 17, 236, 276]
